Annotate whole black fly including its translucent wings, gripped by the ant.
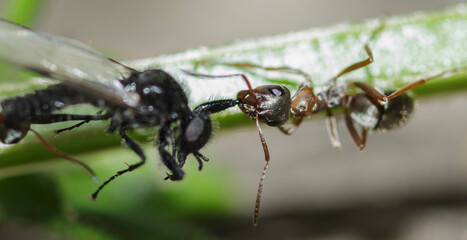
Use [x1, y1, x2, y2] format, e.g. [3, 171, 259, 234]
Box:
[0, 19, 260, 199]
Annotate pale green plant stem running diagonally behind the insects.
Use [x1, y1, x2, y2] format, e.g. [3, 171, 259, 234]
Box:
[0, 4, 467, 177]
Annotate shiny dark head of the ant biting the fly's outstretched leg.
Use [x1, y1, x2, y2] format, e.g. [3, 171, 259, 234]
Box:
[237, 85, 290, 126]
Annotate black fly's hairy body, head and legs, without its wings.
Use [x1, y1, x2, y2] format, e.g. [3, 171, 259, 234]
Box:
[0, 69, 239, 198]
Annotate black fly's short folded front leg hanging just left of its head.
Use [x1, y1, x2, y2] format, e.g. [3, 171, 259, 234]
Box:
[158, 126, 186, 181]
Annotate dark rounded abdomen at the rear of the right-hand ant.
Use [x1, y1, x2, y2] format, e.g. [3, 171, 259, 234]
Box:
[377, 91, 414, 130]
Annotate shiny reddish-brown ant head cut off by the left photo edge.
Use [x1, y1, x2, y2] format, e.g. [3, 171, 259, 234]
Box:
[0, 115, 30, 144]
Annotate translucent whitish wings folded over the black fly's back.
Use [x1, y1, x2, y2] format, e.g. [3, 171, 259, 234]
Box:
[0, 19, 139, 107]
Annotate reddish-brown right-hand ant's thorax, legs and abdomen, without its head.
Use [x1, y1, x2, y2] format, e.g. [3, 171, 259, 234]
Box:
[222, 44, 460, 150]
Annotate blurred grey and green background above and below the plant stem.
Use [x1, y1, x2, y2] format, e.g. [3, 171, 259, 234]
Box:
[0, 0, 467, 240]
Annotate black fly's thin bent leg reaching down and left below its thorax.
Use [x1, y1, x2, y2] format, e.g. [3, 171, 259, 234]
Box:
[90, 126, 146, 200]
